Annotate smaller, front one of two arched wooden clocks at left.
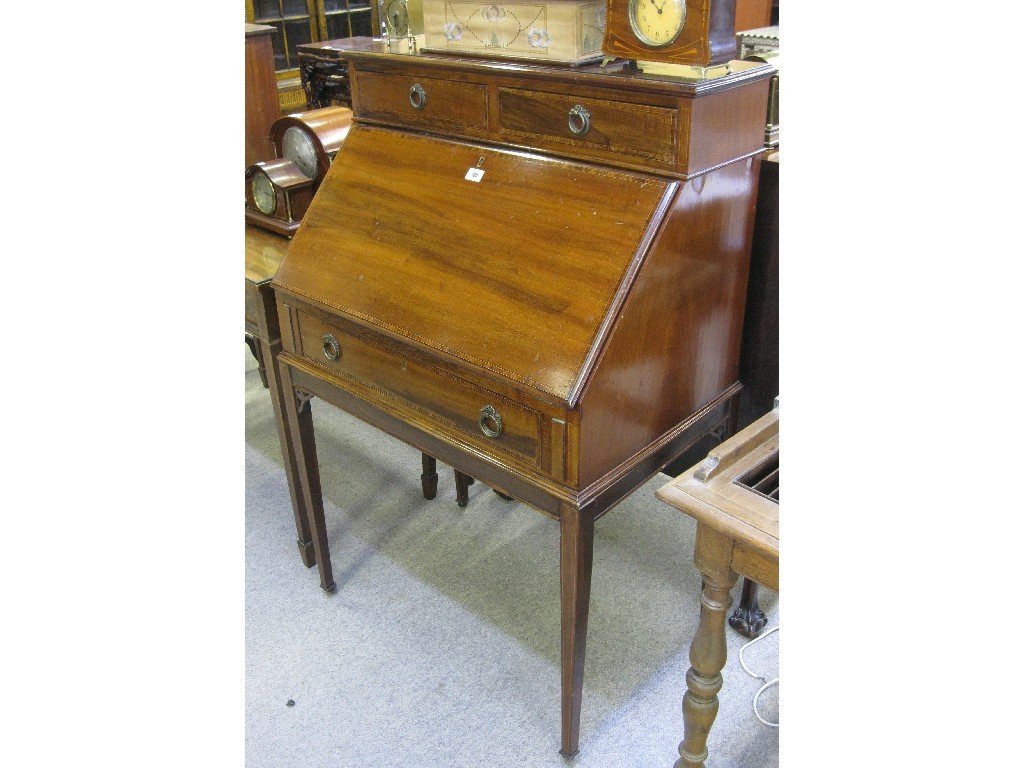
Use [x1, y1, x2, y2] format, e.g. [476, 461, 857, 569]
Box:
[246, 158, 313, 238]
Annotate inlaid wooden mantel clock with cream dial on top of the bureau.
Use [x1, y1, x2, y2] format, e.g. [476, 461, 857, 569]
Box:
[601, 0, 736, 69]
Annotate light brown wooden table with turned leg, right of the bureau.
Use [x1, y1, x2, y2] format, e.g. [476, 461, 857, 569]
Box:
[655, 406, 778, 768]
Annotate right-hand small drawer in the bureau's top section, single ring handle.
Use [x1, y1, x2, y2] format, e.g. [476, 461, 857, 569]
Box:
[498, 88, 679, 165]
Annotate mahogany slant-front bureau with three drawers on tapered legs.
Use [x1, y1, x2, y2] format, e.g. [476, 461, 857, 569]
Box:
[273, 40, 772, 756]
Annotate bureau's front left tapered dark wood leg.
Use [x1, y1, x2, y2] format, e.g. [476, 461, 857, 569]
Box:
[281, 366, 335, 592]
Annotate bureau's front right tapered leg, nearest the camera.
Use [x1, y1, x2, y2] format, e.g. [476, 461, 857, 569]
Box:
[559, 505, 594, 758]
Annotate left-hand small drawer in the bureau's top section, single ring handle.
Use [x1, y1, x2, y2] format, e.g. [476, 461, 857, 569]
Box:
[353, 71, 487, 133]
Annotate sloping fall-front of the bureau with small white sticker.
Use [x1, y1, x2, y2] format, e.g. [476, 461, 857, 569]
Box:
[273, 124, 677, 404]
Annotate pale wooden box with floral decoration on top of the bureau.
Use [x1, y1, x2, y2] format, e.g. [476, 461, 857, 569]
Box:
[423, 0, 605, 65]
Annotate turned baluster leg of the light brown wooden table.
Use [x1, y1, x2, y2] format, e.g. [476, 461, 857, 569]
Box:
[674, 525, 739, 768]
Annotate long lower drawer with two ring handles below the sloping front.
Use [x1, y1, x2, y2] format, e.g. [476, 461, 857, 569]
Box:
[295, 310, 542, 468]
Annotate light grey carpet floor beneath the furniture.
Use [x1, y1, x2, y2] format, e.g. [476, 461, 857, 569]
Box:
[245, 351, 781, 768]
